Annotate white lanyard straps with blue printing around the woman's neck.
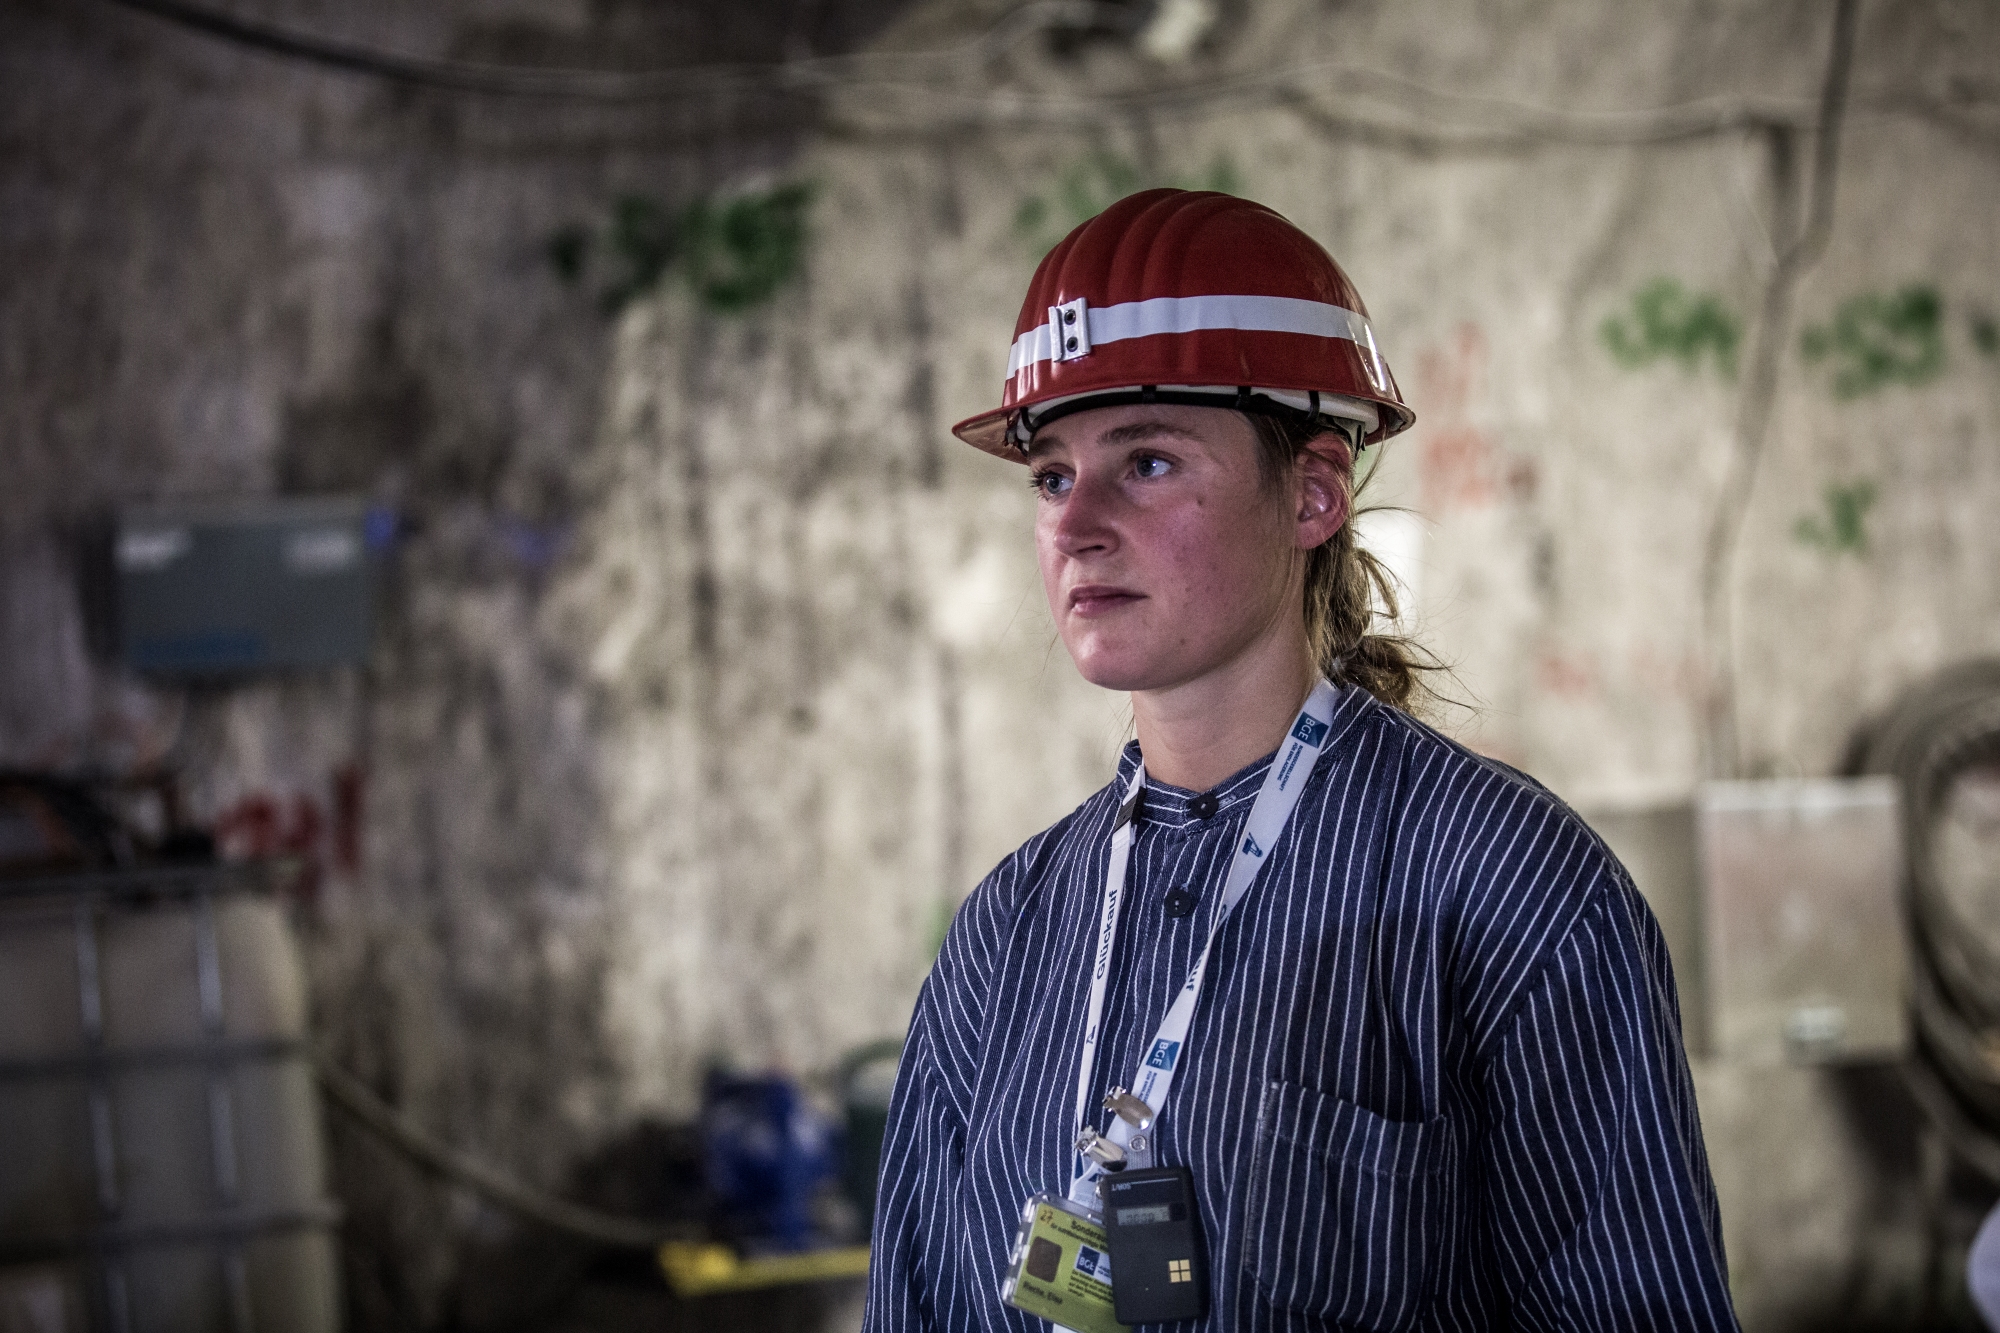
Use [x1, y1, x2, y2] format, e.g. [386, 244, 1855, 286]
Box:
[1070, 681, 1336, 1209]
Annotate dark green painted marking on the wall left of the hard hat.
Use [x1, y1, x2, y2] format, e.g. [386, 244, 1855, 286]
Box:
[548, 182, 812, 314]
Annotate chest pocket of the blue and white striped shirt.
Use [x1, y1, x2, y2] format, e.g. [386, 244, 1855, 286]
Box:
[1244, 1083, 1444, 1333]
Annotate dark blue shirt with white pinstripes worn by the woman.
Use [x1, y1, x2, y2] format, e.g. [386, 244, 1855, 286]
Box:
[864, 689, 1736, 1333]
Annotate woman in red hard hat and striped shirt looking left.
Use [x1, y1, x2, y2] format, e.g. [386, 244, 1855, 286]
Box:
[866, 190, 1734, 1333]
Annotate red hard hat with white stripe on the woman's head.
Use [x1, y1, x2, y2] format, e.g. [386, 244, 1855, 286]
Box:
[952, 190, 1416, 462]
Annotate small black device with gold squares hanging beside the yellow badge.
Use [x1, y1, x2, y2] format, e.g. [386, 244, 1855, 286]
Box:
[1102, 1167, 1208, 1323]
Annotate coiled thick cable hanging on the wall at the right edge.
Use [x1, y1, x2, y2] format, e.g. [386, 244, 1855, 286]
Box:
[1852, 660, 2000, 1183]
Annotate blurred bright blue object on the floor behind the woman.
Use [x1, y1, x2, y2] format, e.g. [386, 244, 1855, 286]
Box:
[702, 1073, 840, 1249]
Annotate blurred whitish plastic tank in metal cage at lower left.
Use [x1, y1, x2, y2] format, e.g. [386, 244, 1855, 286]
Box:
[0, 867, 340, 1333]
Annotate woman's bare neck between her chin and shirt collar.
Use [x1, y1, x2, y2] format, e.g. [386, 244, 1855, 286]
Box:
[1132, 634, 1318, 791]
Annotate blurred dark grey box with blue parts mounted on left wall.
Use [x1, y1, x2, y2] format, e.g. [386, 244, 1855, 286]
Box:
[112, 498, 374, 675]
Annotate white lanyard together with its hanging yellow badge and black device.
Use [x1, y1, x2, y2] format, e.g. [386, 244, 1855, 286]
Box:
[1004, 681, 1338, 1327]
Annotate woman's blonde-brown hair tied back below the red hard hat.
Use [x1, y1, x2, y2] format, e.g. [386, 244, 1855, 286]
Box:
[1244, 412, 1442, 713]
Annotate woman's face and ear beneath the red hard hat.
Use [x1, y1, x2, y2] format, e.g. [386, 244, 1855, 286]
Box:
[1028, 404, 1346, 691]
